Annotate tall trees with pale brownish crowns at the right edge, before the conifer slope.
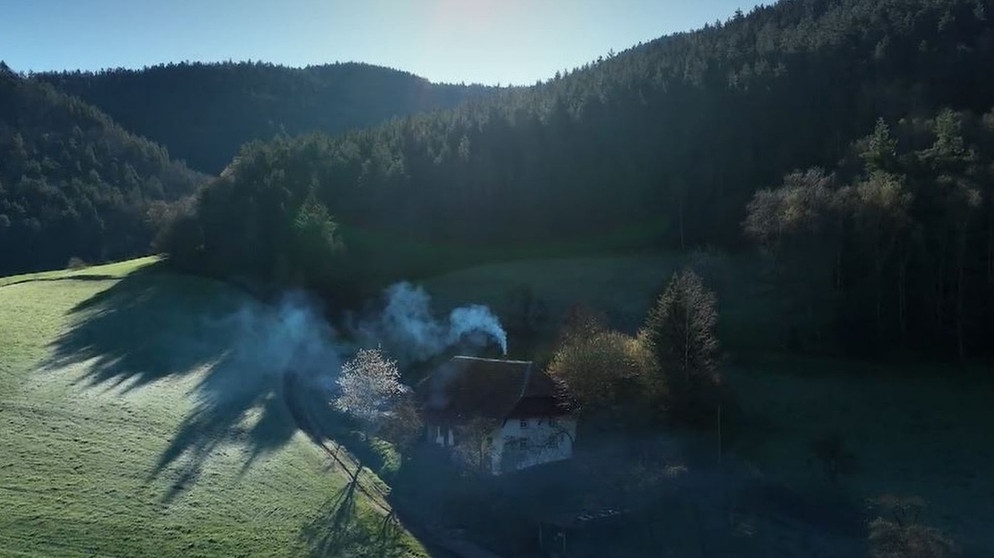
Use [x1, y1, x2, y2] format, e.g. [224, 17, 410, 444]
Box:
[745, 110, 994, 358]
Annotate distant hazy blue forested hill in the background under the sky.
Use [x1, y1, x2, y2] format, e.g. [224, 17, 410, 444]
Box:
[35, 63, 496, 173]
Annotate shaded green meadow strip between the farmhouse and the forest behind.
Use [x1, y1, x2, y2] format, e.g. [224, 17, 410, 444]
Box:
[421, 253, 778, 357]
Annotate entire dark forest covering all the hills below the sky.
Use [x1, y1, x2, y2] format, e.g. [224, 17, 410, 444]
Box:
[0, 0, 994, 358]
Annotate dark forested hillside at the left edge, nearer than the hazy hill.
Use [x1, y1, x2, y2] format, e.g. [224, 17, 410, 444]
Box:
[0, 63, 206, 275]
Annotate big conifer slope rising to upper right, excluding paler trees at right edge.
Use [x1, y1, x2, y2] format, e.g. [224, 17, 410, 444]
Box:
[172, 0, 994, 249]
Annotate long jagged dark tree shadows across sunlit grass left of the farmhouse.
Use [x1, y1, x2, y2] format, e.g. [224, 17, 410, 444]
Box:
[43, 271, 337, 502]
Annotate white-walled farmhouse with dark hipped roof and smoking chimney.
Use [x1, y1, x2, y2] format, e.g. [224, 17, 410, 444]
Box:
[418, 356, 576, 475]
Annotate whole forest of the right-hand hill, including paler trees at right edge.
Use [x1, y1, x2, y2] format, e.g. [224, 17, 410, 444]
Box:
[159, 0, 994, 356]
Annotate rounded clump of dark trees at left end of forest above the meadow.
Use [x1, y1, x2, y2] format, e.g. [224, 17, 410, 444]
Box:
[163, 137, 347, 298]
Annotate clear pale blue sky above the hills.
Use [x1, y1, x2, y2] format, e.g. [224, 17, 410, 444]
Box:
[0, 0, 755, 85]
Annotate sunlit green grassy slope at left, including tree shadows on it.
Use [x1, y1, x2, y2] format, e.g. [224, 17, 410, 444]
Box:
[0, 259, 422, 557]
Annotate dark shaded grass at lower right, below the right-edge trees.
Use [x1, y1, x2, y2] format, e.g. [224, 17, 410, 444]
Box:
[727, 356, 994, 556]
